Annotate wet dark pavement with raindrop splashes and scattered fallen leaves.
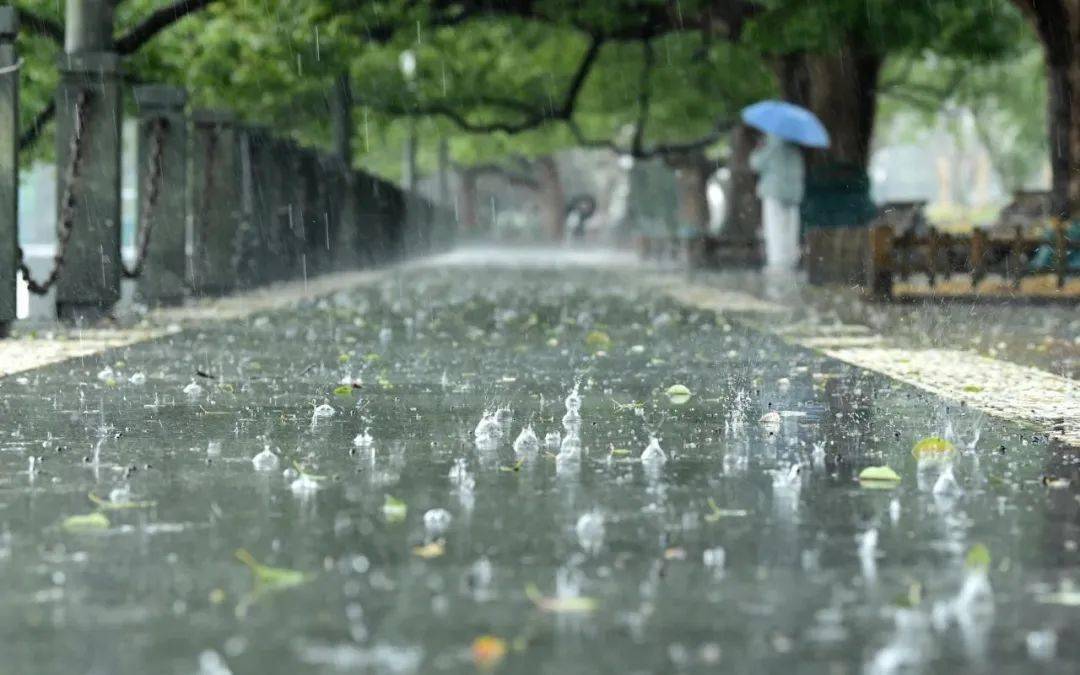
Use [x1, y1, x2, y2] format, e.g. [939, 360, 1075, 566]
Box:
[0, 254, 1080, 674]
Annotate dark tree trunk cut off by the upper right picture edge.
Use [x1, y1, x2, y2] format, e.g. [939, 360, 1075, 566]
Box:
[1013, 0, 1080, 217]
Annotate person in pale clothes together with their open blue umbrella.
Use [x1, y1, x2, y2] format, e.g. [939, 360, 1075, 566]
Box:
[742, 100, 828, 271]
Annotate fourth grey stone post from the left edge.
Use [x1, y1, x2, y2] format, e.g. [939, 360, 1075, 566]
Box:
[189, 110, 243, 295]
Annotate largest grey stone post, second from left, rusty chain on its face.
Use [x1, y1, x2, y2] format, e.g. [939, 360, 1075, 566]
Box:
[56, 52, 122, 321]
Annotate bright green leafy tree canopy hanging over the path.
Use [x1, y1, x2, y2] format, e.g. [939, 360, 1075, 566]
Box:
[6, 0, 1043, 185]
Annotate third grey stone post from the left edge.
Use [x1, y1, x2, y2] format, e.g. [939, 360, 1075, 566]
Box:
[135, 85, 188, 305]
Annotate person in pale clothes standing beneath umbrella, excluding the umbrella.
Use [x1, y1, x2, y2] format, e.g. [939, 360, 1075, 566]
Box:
[750, 134, 806, 271]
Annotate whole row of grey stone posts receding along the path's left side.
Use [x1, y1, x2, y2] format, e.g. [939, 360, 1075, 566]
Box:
[0, 8, 455, 337]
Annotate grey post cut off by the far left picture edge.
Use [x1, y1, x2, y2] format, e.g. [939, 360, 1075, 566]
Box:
[0, 6, 18, 337]
